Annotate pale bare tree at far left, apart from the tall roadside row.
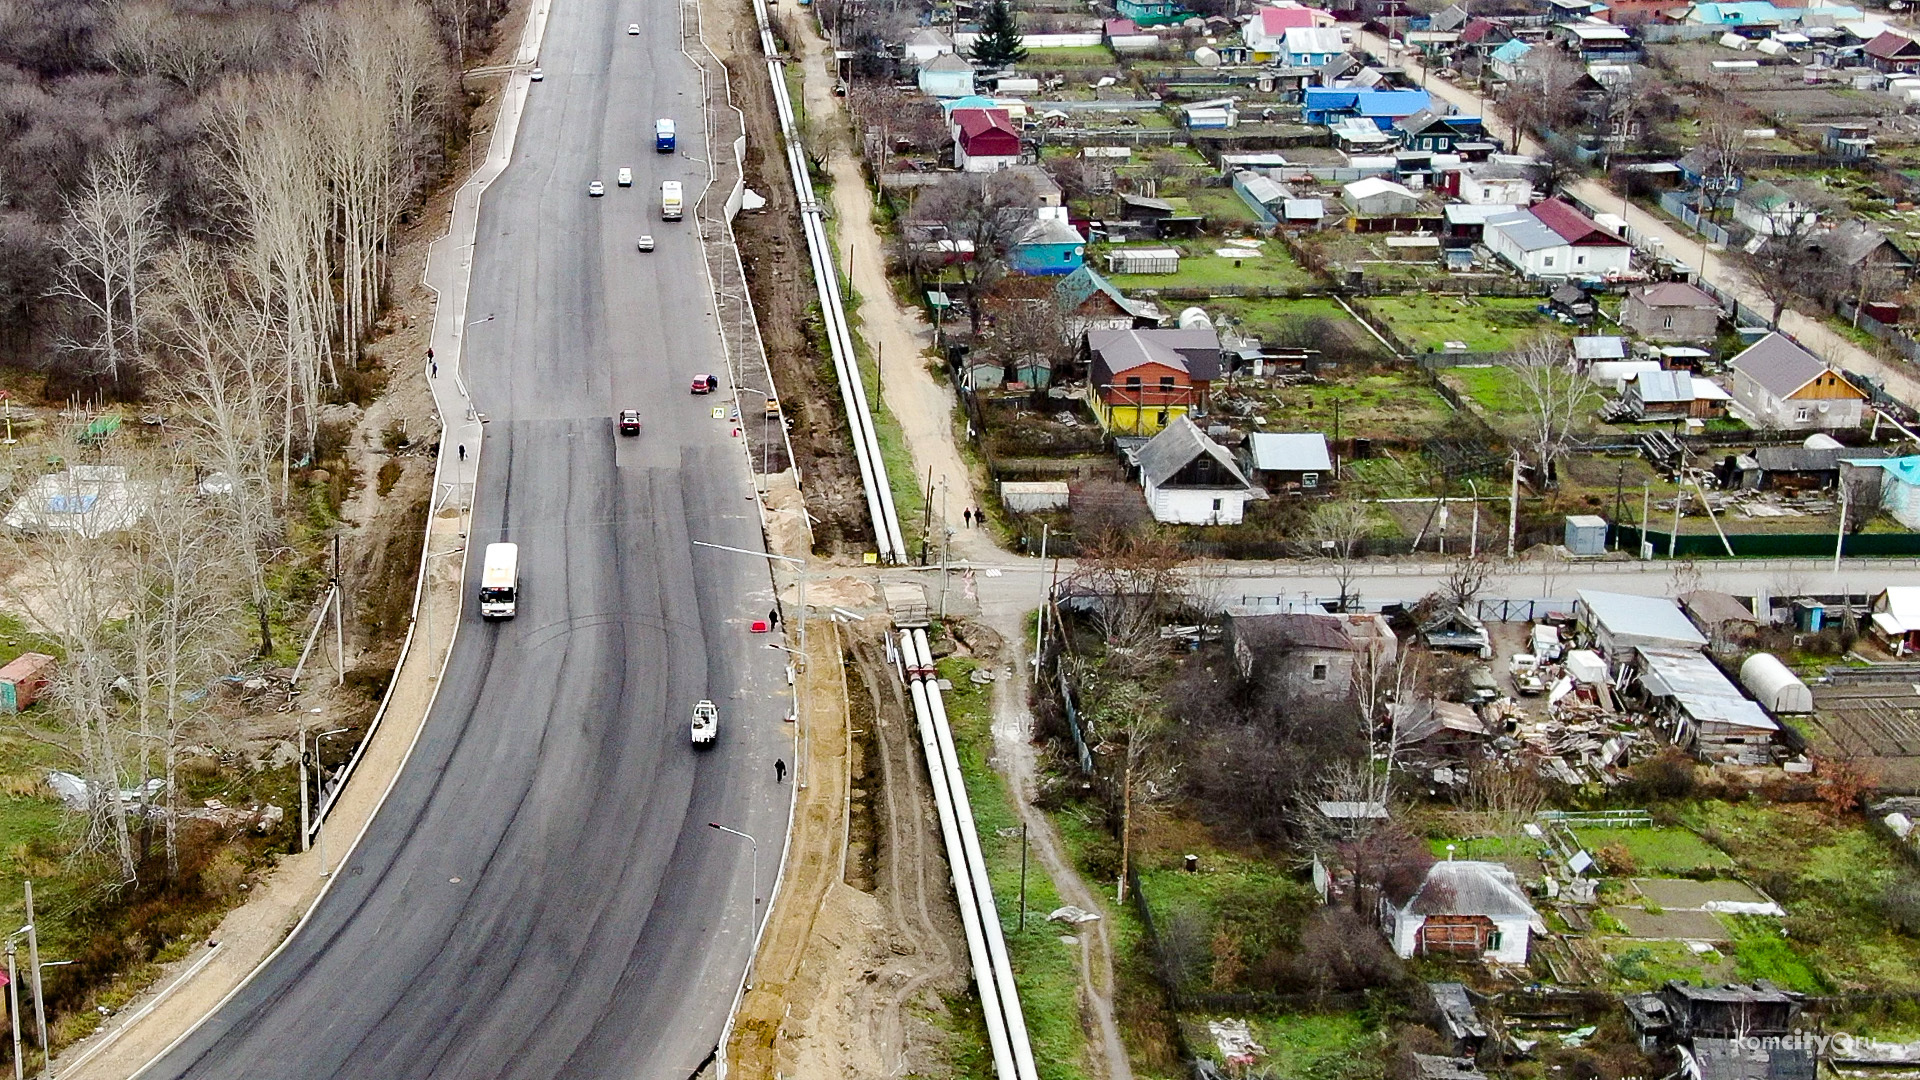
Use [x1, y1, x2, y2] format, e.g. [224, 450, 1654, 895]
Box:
[50, 138, 163, 382]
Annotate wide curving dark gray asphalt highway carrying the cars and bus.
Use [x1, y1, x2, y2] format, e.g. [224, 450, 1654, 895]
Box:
[146, 0, 791, 1080]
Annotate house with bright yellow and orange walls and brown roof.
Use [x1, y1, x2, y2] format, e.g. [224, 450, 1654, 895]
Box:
[1081, 329, 1221, 434]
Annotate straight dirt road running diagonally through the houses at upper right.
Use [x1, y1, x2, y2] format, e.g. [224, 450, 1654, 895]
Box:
[1354, 31, 1920, 407]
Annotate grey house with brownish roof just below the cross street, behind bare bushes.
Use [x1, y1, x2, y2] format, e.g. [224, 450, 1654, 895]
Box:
[1223, 609, 1400, 701]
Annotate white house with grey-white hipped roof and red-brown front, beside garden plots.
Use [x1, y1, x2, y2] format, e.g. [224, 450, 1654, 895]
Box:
[1380, 859, 1540, 965]
